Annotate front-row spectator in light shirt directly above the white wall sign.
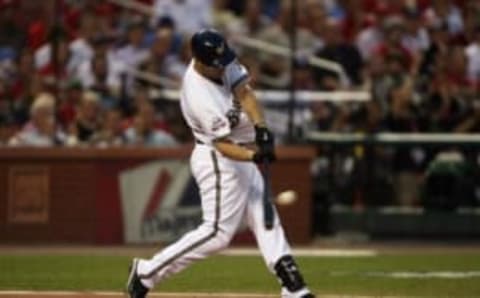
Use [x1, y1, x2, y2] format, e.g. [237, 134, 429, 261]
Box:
[125, 102, 177, 147]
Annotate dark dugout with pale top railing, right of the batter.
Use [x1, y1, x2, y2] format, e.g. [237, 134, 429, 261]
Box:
[305, 131, 480, 238]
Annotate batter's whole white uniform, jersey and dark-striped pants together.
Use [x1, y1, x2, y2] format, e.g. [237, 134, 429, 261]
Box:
[137, 61, 308, 298]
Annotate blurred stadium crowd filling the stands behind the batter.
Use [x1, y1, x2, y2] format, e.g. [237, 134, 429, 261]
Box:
[0, 0, 480, 204]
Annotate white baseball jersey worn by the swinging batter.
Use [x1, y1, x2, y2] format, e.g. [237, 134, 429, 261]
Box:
[180, 60, 255, 144]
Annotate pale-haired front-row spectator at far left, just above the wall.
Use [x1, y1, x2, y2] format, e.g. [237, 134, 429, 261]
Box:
[8, 93, 65, 147]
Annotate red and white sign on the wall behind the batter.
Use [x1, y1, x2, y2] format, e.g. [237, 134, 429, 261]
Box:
[119, 160, 201, 243]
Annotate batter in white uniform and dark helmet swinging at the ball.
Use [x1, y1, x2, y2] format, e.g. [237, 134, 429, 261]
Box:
[127, 29, 314, 298]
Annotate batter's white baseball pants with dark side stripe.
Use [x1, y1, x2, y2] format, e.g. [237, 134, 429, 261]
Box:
[137, 144, 291, 288]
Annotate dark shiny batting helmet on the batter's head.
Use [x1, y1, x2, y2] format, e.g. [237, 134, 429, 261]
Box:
[191, 29, 235, 68]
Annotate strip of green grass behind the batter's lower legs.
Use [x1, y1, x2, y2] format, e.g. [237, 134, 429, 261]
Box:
[0, 253, 480, 297]
